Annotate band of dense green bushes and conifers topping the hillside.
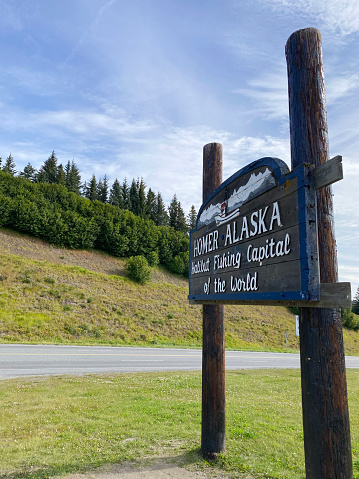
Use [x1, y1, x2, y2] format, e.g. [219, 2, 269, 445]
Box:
[0, 154, 194, 276]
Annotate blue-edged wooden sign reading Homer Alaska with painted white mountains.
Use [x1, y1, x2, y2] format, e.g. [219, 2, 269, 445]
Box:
[189, 158, 320, 304]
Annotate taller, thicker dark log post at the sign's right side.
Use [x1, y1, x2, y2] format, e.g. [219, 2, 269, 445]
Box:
[286, 28, 353, 479]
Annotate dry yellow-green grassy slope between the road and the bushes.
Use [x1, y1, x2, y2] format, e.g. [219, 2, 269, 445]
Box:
[0, 228, 359, 354]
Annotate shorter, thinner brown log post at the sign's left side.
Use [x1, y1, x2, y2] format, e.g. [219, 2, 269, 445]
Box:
[202, 143, 226, 458]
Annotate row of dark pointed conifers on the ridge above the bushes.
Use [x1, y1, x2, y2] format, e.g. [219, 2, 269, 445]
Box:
[0, 151, 197, 232]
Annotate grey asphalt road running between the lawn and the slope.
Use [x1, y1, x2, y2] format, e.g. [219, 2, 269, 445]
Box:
[0, 344, 359, 379]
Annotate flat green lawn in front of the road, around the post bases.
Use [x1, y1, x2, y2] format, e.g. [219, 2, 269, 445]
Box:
[0, 370, 359, 479]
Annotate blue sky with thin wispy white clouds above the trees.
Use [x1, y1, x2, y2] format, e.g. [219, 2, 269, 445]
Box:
[0, 0, 359, 294]
